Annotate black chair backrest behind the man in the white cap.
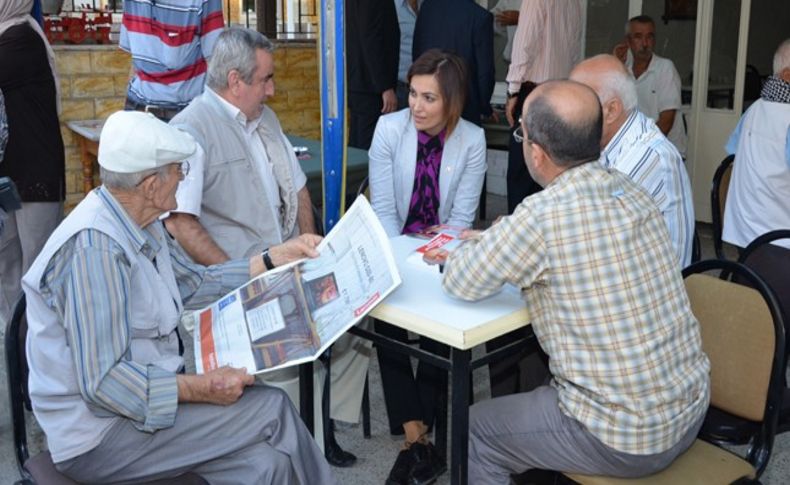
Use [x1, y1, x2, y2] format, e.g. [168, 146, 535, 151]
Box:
[5, 294, 32, 480]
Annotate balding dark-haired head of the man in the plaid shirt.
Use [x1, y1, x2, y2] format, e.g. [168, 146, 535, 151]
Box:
[522, 81, 601, 168]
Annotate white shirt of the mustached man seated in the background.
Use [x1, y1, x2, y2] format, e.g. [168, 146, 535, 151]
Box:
[625, 51, 687, 158]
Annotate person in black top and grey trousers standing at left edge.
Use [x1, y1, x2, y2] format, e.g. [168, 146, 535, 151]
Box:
[0, 0, 66, 321]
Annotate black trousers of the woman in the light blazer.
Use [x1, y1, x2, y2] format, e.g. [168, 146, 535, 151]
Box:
[374, 320, 450, 436]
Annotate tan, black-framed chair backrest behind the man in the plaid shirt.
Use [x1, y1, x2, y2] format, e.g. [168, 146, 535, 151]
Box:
[683, 260, 785, 464]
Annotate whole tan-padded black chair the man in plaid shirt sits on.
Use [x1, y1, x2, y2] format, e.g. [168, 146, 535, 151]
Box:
[568, 260, 785, 485]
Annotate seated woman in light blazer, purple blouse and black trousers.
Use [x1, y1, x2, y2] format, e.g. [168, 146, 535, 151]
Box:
[369, 49, 486, 484]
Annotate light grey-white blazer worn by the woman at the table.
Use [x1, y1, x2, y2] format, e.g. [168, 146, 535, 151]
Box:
[368, 108, 487, 237]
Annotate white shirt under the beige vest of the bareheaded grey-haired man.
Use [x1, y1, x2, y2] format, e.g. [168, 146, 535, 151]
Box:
[174, 87, 307, 237]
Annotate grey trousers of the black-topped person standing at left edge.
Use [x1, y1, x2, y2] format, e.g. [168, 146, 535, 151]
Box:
[0, 202, 63, 322]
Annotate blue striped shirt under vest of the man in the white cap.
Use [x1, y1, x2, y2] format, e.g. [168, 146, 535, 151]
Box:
[41, 186, 249, 432]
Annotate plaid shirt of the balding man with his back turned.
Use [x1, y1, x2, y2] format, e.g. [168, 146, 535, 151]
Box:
[444, 163, 710, 455]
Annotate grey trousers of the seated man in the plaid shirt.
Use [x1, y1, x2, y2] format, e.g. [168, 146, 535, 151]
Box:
[469, 386, 704, 485]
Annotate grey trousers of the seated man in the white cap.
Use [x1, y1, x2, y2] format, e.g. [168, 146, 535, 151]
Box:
[55, 386, 337, 485]
